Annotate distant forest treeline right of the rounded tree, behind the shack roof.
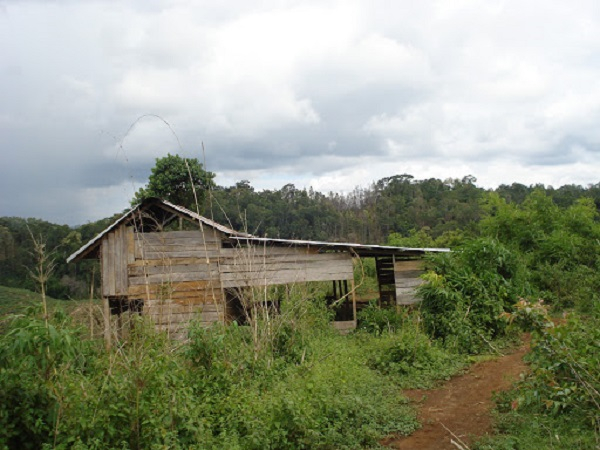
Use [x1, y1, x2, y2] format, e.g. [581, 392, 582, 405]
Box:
[205, 174, 600, 244]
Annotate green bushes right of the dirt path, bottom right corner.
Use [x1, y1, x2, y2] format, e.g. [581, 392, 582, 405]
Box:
[476, 314, 600, 449]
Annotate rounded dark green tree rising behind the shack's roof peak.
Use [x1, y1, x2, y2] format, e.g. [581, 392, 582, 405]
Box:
[131, 154, 215, 212]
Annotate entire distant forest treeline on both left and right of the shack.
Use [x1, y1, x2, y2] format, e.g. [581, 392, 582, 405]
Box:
[0, 174, 600, 298]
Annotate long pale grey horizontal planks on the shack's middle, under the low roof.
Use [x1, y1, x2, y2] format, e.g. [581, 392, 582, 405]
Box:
[219, 247, 353, 288]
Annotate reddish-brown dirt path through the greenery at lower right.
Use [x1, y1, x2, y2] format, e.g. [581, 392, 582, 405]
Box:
[383, 344, 529, 450]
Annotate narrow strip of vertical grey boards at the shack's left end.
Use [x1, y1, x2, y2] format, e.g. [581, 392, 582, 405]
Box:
[101, 225, 133, 297]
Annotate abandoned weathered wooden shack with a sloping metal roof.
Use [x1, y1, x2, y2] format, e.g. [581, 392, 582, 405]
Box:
[67, 198, 448, 345]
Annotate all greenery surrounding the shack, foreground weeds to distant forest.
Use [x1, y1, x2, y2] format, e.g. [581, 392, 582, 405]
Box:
[0, 163, 600, 449]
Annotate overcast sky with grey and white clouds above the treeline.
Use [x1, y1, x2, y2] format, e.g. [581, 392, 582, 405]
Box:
[0, 0, 600, 225]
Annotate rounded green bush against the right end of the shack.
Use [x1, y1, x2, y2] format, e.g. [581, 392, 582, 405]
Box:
[419, 239, 527, 353]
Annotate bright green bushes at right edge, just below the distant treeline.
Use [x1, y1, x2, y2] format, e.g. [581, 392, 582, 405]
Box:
[480, 189, 600, 311]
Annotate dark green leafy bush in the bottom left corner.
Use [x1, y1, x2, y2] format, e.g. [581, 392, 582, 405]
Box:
[0, 307, 88, 449]
